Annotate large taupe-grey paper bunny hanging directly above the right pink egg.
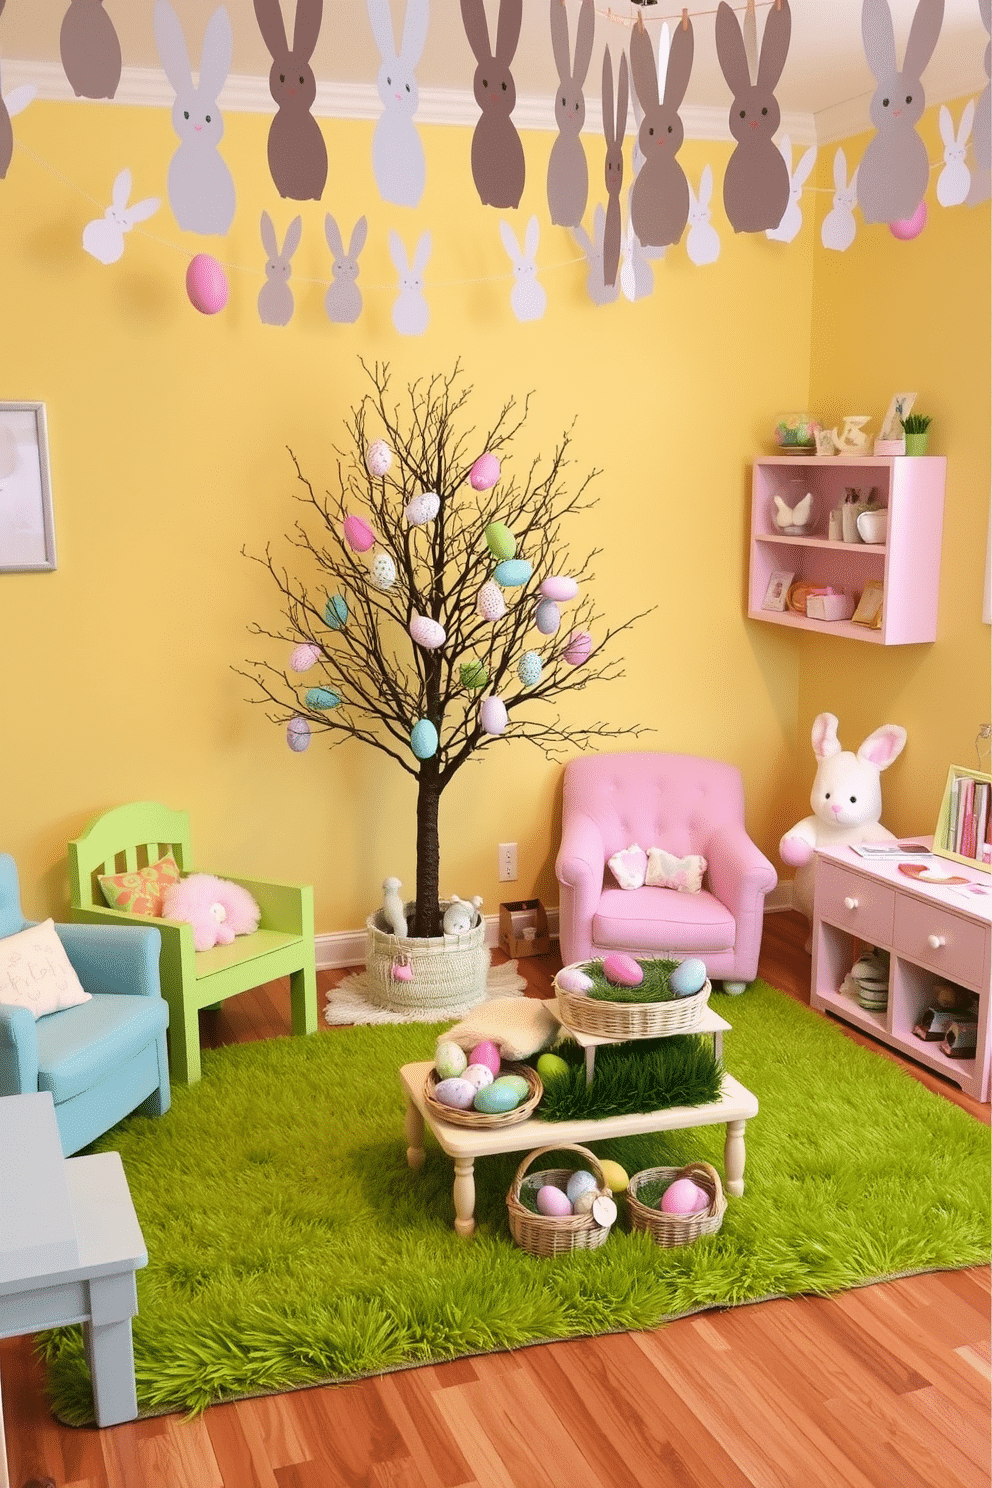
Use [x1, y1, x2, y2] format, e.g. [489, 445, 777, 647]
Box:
[858, 0, 944, 222]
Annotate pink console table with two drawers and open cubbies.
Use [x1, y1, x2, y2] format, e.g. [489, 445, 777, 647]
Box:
[811, 838, 992, 1101]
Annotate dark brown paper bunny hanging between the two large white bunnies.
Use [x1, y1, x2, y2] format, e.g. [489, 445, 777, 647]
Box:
[254, 0, 327, 201]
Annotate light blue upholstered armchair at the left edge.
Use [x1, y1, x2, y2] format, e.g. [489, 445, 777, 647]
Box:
[0, 853, 171, 1158]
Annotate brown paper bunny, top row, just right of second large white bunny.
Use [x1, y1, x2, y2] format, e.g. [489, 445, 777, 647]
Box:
[461, 0, 525, 207]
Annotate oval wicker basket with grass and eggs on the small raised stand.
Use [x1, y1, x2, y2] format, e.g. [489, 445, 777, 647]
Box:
[555, 951, 711, 1039]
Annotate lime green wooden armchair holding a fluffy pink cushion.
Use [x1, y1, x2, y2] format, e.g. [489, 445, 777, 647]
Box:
[68, 801, 317, 1085]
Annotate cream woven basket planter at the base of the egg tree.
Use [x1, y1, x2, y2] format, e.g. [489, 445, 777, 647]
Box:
[366, 903, 489, 1019]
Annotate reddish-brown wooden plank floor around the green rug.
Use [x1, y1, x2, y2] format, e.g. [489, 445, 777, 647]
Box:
[0, 912, 991, 1488]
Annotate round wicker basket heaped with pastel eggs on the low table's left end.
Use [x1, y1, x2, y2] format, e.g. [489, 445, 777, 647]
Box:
[424, 1040, 544, 1128]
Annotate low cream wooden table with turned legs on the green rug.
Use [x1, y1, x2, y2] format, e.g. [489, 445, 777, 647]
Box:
[400, 1059, 759, 1238]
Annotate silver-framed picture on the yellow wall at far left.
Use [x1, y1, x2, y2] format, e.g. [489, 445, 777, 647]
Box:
[0, 402, 57, 573]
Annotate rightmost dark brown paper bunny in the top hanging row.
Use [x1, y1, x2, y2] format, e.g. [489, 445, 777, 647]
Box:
[717, 0, 793, 232]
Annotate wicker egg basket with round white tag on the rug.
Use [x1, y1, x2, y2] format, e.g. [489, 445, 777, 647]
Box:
[506, 1143, 626, 1256]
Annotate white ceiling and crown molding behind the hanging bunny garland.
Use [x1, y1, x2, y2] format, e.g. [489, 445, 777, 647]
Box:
[0, 0, 988, 140]
